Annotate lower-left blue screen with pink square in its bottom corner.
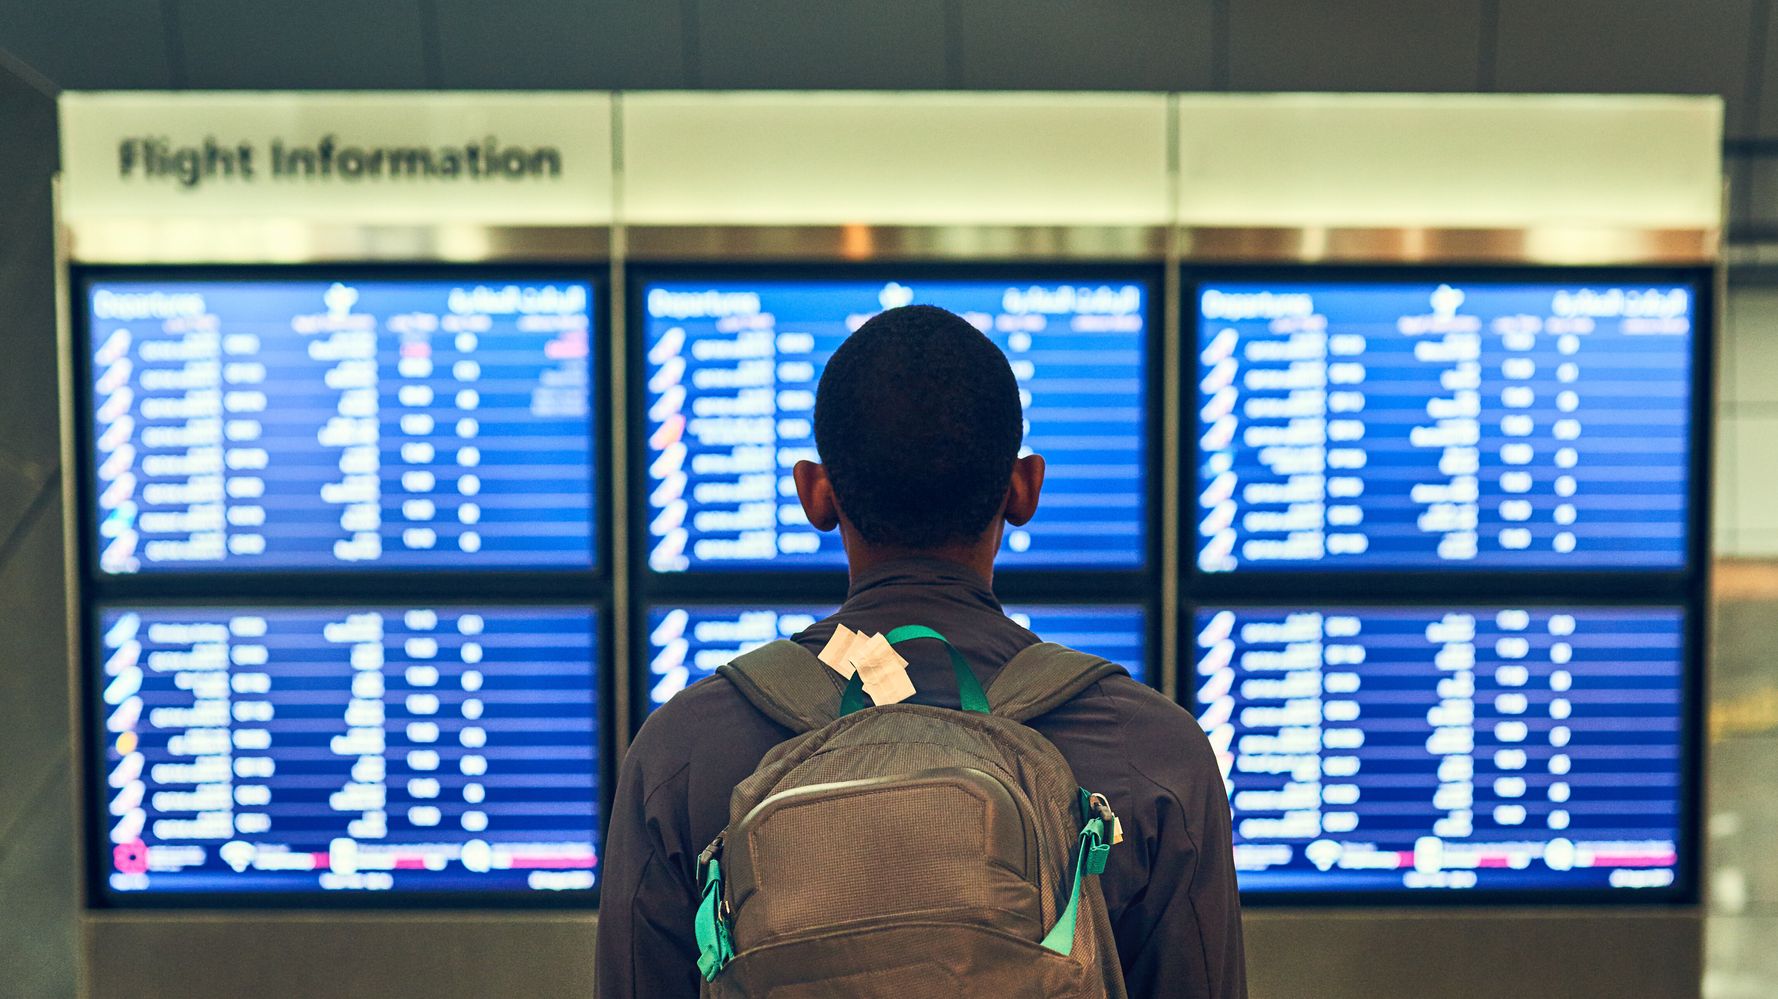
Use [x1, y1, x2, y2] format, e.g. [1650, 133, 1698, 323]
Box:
[96, 606, 599, 899]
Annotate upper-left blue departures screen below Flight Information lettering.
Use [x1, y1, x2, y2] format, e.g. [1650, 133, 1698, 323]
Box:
[87, 279, 596, 574]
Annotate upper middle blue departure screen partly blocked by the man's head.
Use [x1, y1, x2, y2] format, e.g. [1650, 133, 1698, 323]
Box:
[642, 281, 1149, 572]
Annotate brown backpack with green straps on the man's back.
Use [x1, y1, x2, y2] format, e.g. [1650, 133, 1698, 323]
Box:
[697, 626, 1124, 999]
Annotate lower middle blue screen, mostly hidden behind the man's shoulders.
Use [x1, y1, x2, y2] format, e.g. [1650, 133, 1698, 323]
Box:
[642, 604, 1149, 711]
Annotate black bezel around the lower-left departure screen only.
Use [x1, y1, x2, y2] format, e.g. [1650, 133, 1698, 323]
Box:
[80, 595, 617, 910]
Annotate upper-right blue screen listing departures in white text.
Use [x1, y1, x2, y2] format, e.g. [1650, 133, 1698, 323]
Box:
[1193, 283, 1693, 572]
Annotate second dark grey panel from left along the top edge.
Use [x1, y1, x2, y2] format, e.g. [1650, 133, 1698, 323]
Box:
[169, 0, 427, 91]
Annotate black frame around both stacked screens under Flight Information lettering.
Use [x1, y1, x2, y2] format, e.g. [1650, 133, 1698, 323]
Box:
[66, 261, 626, 910]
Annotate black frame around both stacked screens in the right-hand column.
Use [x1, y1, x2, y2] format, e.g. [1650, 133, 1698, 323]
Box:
[1173, 265, 1719, 908]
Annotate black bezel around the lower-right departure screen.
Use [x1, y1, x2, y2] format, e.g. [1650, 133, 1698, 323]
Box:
[1179, 592, 1707, 908]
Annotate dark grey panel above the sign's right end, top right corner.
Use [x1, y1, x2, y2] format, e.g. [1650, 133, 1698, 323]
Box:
[1494, 0, 1755, 135]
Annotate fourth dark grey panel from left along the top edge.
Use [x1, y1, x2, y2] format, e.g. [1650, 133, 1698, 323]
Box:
[697, 0, 951, 89]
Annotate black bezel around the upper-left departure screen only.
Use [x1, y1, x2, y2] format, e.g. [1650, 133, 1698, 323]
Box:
[69, 263, 615, 599]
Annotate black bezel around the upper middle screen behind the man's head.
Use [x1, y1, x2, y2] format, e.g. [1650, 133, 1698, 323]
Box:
[626, 261, 1165, 597]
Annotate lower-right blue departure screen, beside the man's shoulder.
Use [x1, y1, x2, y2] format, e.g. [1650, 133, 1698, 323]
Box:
[1193, 608, 1686, 894]
